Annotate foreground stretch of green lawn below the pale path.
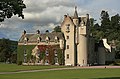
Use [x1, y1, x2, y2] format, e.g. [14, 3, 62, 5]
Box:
[0, 68, 120, 79]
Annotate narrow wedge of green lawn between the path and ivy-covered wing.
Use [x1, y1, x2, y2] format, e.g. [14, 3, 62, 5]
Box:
[0, 64, 66, 72]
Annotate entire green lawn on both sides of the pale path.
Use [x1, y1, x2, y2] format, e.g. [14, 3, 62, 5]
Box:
[0, 64, 120, 79]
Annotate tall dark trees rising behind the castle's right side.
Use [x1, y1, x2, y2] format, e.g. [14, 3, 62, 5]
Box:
[90, 10, 120, 50]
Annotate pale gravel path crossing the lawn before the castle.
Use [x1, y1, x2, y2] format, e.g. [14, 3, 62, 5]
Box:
[0, 66, 120, 75]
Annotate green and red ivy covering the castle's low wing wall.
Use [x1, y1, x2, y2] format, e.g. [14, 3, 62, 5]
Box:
[17, 45, 64, 65]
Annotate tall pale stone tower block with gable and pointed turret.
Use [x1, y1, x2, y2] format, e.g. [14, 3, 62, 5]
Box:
[61, 7, 89, 66]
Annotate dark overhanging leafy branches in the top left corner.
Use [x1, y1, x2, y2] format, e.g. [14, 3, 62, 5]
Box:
[0, 0, 26, 22]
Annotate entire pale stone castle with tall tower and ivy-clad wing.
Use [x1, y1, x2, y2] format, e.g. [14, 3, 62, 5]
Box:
[17, 7, 114, 66]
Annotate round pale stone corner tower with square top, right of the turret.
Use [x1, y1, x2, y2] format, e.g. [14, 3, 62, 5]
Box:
[77, 14, 89, 66]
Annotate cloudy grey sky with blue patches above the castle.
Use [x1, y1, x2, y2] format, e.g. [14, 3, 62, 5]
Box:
[0, 0, 120, 40]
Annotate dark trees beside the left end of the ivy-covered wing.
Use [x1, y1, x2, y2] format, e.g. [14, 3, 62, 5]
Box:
[0, 38, 17, 62]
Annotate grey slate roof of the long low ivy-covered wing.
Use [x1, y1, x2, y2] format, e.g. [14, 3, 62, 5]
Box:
[19, 32, 64, 43]
